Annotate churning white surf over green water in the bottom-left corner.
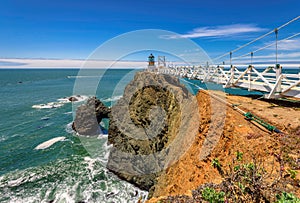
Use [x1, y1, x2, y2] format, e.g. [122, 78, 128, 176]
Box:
[0, 156, 148, 203]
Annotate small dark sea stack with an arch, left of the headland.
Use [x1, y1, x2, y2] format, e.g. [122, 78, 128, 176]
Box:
[72, 97, 110, 135]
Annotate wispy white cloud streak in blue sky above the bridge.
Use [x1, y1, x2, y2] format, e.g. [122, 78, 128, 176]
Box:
[163, 24, 265, 39]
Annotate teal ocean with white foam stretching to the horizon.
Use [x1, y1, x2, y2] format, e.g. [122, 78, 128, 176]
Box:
[0, 69, 297, 202]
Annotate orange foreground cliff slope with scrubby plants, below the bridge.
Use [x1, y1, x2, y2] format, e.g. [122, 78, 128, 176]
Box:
[147, 91, 300, 203]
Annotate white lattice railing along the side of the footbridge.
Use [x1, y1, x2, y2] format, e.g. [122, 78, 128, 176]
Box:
[159, 65, 300, 99]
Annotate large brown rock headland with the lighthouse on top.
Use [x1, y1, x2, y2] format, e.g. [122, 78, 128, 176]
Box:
[107, 72, 199, 193]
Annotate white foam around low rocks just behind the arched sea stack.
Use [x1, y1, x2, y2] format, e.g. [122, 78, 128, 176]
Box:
[32, 95, 89, 109]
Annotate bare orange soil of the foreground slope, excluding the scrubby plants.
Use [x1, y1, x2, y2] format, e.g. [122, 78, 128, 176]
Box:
[148, 91, 300, 202]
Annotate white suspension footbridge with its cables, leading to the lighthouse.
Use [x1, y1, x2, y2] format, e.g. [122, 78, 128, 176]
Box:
[152, 16, 300, 99]
